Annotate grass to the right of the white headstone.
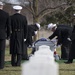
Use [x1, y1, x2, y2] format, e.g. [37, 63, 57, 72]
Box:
[56, 48, 75, 75]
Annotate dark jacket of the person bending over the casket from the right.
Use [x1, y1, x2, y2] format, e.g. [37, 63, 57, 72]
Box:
[49, 25, 72, 44]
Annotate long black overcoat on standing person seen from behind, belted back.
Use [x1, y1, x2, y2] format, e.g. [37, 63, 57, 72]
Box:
[10, 13, 27, 54]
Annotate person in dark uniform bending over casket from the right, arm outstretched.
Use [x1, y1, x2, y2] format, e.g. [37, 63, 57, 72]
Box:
[48, 24, 72, 60]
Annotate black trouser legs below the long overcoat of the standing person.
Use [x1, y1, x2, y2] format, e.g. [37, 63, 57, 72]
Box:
[11, 54, 22, 66]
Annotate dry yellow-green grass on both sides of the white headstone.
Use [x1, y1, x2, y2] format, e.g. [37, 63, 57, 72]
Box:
[0, 48, 75, 75]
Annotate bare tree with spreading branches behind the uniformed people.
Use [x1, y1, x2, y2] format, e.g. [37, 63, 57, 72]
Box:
[2, 0, 75, 39]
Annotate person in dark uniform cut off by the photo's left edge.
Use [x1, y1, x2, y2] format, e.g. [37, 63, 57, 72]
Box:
[0, 2, 10, 69]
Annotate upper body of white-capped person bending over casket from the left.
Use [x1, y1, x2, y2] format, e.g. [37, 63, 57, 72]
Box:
[26, 23, 40, 46]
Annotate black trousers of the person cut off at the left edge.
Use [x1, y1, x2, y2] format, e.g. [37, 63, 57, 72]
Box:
[0, 39, 5, 69]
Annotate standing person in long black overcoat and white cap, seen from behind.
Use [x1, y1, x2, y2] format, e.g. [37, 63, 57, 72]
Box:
[10, 6, 28, 66]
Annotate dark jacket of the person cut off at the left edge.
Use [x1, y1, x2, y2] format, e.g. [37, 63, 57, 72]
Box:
[0, 10, 10, 39]
